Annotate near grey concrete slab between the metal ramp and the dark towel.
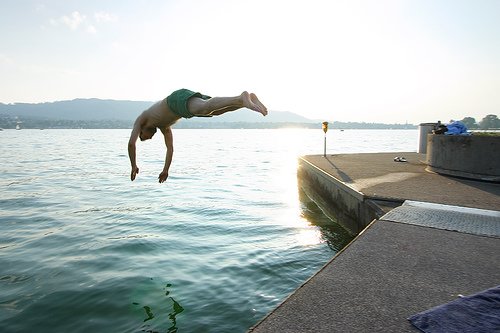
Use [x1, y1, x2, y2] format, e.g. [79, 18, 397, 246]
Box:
[250, 220, 500, 333]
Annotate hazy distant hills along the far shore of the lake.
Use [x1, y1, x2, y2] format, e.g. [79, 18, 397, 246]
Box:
[0, 98, 416, 129]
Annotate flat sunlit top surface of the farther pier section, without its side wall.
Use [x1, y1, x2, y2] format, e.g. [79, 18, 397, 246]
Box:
[302, 152, 500, 210]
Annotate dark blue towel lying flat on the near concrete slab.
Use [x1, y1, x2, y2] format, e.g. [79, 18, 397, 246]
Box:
[408, 286, 500, 333]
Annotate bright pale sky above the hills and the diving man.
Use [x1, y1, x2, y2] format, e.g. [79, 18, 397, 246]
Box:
[0, 0, 500, 124]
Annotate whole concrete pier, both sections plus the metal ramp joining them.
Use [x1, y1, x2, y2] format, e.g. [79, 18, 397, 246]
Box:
[250, 153, 500, 333]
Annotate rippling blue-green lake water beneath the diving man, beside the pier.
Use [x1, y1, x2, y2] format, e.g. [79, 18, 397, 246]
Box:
[0, 129, 418, 332]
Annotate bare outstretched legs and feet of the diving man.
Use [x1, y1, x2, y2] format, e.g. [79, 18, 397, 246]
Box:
[188, 91, 267, 116]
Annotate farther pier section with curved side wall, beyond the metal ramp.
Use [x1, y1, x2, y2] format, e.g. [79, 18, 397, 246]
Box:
[298, 152, 500, 234]
